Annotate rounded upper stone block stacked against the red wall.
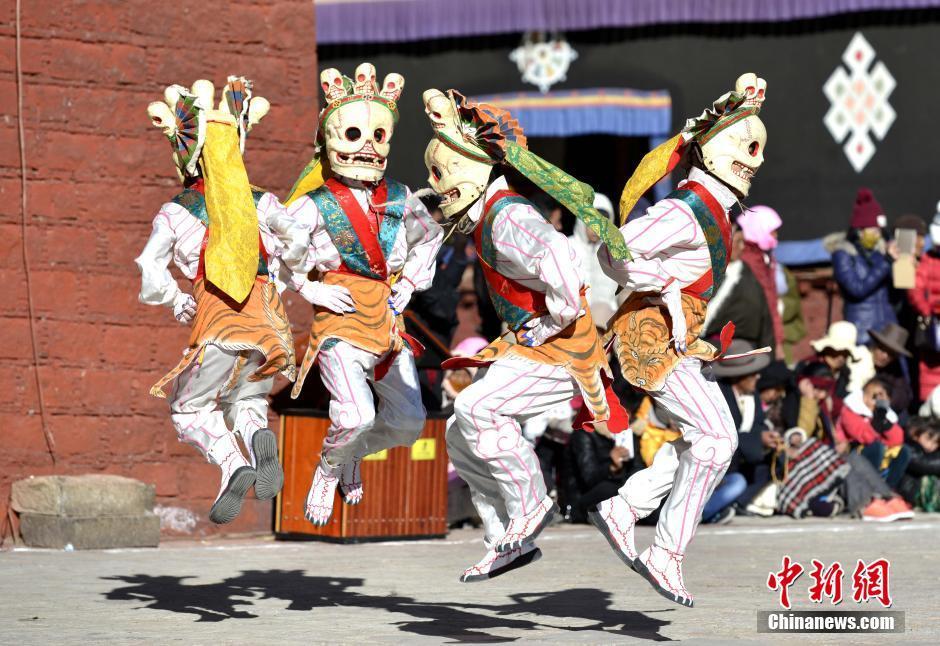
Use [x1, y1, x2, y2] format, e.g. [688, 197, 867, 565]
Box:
[12, 474, 155, 518]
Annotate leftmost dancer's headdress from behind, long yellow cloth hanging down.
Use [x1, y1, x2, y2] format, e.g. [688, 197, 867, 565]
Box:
[147, 76, 270, 303]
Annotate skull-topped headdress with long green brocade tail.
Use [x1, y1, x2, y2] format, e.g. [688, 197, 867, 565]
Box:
[424, 90, 630, 259]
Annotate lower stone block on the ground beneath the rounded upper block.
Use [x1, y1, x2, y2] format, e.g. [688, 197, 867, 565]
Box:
[20, 512, 160, 550]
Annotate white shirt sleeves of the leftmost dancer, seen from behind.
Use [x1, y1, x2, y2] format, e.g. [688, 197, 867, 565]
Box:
[135, 193, 307, 307]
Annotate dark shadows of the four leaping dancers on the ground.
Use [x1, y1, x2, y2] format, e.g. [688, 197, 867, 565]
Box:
[103, 570, 669, 643]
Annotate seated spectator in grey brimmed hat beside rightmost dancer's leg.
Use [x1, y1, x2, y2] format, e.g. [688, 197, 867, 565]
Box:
[702, 339, 781, 508]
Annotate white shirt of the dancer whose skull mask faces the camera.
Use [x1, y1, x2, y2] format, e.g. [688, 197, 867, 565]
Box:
[288, 186, 444, 292]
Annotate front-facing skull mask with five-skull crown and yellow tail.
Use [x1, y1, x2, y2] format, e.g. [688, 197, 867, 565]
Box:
[284, 63, 405, 204]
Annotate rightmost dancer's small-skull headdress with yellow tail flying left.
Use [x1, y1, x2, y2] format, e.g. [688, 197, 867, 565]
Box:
[620, 72, 767, 222]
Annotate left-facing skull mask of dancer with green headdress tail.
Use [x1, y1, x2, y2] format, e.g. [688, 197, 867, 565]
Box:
[424, 139, 493, 219]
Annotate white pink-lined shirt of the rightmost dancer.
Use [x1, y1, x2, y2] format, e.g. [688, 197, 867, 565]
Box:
[598, 168, 737, 292]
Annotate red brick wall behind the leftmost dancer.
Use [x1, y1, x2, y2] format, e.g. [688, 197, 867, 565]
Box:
[0, 0, 317, 535]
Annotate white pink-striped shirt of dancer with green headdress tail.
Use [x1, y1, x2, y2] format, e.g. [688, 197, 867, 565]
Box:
[467, 177, 584, 327]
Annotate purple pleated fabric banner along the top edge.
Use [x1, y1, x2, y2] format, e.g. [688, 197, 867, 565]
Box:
[316, 0, 940, 45]
